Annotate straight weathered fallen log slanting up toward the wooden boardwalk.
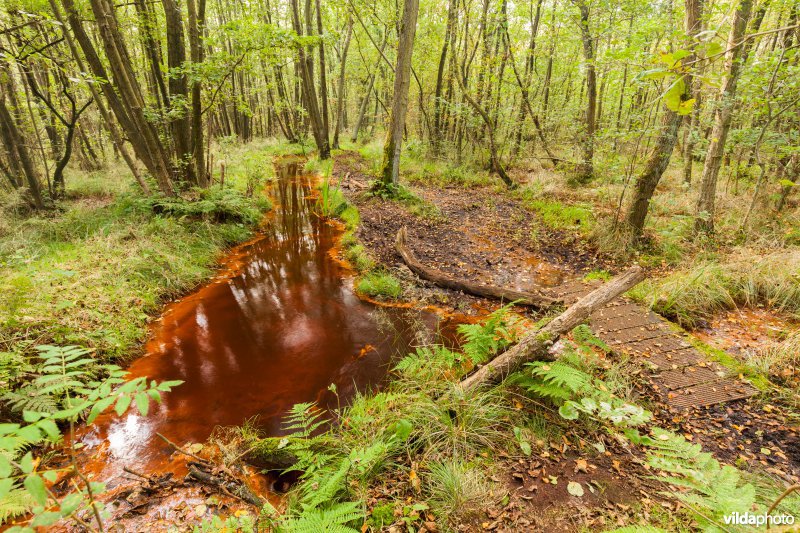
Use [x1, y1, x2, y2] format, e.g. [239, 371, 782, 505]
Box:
[461, 266, 644, 390]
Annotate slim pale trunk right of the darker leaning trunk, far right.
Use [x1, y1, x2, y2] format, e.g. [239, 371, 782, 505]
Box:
[694, 0, 753, 234]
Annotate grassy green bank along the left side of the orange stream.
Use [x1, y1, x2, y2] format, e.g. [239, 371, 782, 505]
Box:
[0, 148, 269, 359]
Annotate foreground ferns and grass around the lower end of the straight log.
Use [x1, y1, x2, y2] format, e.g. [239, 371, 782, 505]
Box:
[222, 307, 800, 532]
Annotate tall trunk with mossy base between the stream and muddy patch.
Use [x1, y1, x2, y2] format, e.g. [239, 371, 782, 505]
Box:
[381, 0, 419, 188]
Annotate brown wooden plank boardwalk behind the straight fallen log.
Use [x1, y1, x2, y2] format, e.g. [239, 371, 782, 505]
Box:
[549, 280, 759, 409]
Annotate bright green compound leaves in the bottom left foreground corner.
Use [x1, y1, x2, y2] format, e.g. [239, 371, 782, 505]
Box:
[0, 345, 181, 532]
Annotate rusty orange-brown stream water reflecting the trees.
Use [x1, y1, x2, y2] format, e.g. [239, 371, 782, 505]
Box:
[78, 160, 440, 498]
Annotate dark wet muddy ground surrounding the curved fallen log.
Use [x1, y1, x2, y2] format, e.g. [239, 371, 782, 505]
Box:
[334, 152, 614, 314]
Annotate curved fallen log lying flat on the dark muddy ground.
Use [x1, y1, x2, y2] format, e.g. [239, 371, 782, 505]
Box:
[395, 227, 559, 307]
